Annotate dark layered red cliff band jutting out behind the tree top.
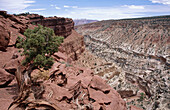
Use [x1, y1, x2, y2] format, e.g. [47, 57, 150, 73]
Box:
[28, 14, 74, 38]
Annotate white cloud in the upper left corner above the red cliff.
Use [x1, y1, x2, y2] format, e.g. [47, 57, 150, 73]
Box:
[0, 0, 35, 13]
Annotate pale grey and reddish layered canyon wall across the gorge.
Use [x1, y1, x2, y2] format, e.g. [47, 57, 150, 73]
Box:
[76, 16, 170, 109]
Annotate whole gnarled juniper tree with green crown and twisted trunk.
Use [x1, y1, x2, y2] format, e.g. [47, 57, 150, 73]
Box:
[8, 25, 64, 110]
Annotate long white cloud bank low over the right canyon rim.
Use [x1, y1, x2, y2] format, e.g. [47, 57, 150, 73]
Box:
[54, 5, 170, 20]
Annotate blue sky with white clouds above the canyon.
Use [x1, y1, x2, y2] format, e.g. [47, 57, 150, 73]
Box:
[0, 0, 170, 20]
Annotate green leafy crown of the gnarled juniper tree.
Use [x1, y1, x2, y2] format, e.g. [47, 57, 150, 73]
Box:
[16, 25, 64, 69]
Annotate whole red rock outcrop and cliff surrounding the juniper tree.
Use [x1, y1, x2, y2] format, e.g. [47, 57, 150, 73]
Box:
[0, 11, 128, 110]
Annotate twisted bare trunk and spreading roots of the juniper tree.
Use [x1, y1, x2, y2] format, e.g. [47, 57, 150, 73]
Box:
[8, 65, 60, 110]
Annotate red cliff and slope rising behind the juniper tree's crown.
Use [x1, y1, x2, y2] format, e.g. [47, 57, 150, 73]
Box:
[0, 11, 84, 60]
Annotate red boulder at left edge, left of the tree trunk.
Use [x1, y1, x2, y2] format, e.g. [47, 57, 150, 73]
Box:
[0, 68, 15, 87]
